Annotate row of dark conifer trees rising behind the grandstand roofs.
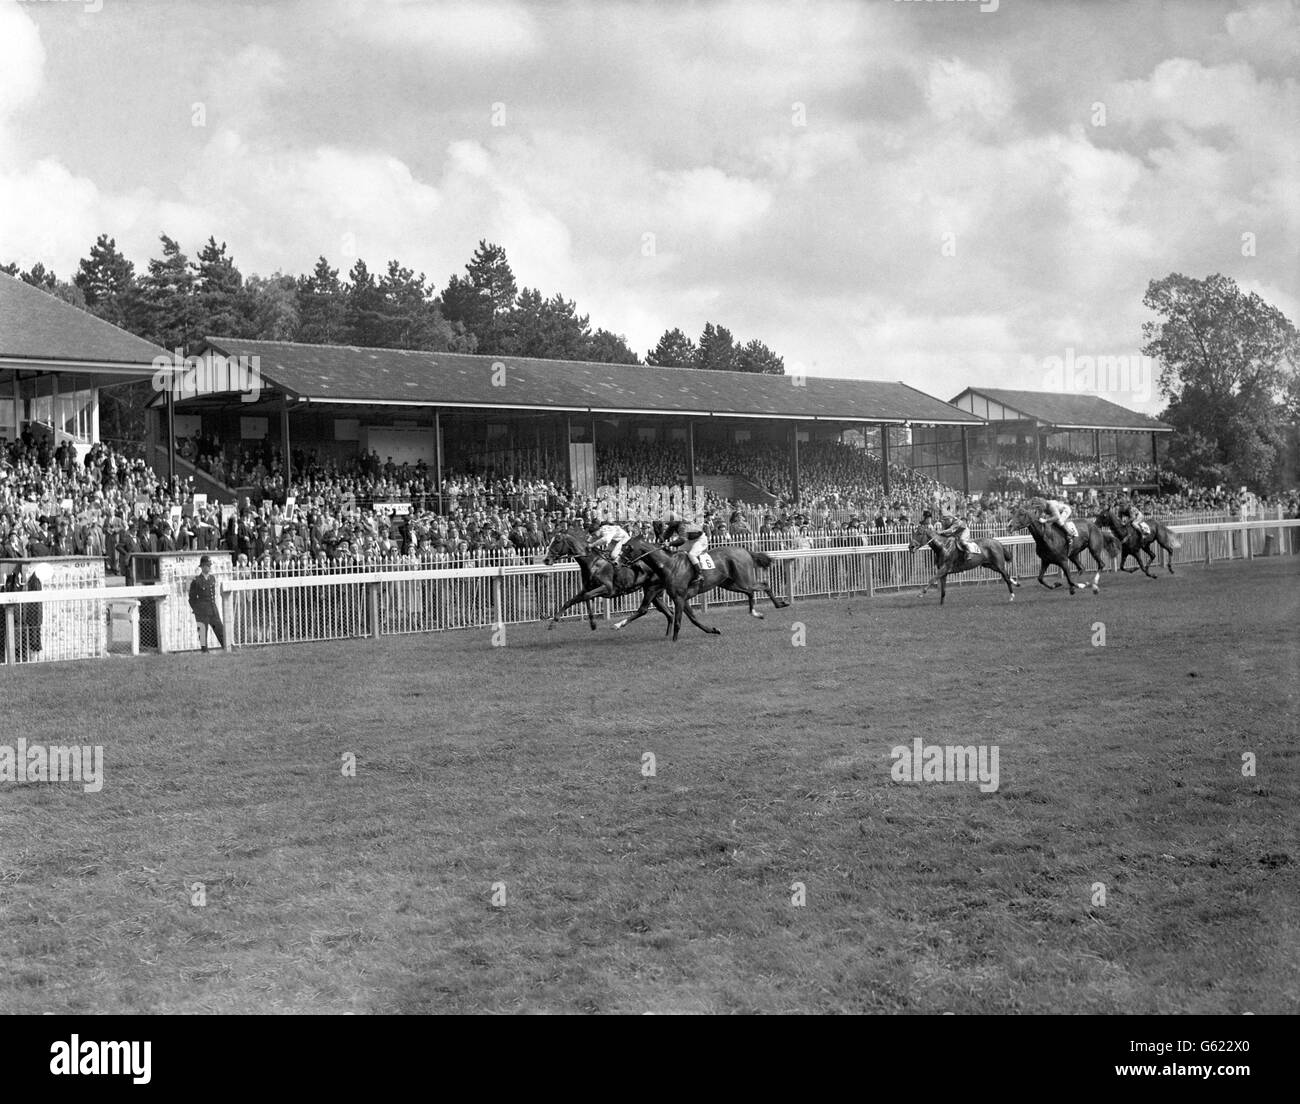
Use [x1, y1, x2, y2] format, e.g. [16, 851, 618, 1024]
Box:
[0, 234, 785, 375]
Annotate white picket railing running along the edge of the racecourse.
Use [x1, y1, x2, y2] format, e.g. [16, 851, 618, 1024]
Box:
[0, 520, 1300, 663]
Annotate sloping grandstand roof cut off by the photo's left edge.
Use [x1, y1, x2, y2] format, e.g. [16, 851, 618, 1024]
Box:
[0, 273, 168, 368]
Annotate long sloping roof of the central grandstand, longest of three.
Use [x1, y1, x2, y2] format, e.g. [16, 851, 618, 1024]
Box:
[197, 337, 984, 425]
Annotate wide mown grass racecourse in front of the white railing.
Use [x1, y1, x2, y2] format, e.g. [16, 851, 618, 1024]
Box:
[0, 559, 1300, 1013]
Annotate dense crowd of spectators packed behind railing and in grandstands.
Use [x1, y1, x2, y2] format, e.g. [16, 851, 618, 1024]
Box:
[0, 430, 1300, 579]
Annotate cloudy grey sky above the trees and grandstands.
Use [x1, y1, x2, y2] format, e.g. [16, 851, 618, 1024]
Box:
[0, 0, 1300, 412]
